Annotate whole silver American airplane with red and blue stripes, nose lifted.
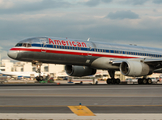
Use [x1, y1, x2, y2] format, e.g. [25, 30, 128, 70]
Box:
[8, 37, 162, 84]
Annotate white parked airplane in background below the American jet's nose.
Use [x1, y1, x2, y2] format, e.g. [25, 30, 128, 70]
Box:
[0, 70, 43, 78]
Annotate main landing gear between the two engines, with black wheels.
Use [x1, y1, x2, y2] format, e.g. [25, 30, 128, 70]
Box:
[107, 70, 120, 84]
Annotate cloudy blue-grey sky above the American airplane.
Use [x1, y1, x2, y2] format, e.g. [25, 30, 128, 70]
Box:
[0, 0, 162, 58]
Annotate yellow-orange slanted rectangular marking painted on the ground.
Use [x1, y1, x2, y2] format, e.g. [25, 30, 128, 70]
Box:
[68, 106, 96, 116]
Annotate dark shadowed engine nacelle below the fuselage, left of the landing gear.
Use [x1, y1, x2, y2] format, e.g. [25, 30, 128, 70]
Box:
[65, 65, 96, 77]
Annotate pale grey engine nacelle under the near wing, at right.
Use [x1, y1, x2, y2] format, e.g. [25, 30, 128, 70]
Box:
[120, 60, 153, 77]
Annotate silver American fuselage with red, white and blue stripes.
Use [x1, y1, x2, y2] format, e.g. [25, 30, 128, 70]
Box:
[8, 37, 162, 69]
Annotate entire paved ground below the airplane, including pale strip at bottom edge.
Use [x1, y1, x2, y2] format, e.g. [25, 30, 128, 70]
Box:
[0, 80, 162, 120]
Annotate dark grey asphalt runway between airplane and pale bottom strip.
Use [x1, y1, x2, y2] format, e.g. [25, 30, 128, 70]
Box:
[0, 84, 162, 114]
